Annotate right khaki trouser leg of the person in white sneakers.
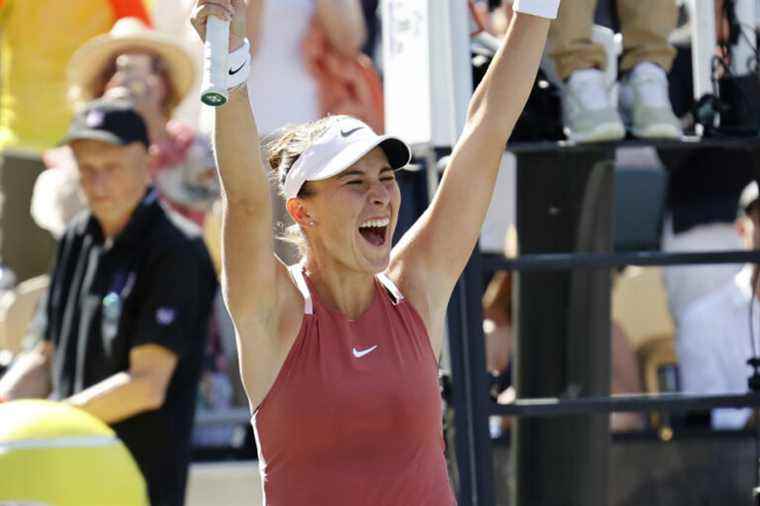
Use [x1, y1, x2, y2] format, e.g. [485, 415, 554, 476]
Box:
[616, 0, 678, 72]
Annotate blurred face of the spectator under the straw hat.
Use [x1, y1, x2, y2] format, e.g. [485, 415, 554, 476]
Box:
[104, 53, 168, 114]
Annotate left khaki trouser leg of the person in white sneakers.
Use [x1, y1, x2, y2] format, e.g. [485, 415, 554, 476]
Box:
[548, 0, 607, 81]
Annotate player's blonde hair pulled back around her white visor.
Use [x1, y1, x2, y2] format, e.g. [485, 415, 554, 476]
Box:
[261, 115, 347, 258]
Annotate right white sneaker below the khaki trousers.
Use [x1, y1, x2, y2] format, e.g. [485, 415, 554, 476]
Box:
[620, 62, 683, 139]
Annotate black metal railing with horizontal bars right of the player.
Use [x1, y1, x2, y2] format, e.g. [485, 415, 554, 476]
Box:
[448, 139, 760, 506]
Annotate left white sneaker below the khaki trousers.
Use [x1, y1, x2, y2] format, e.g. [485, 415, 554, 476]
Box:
[562, 69, 625, 142]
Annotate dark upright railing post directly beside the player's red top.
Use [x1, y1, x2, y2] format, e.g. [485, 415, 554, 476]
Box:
[448, 242, 494, 506]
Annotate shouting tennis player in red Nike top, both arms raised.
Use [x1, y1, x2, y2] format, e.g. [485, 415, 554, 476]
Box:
[193, 0, 559, 506]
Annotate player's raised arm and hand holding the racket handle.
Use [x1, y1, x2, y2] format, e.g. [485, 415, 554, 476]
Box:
[192, 0, 277, 325]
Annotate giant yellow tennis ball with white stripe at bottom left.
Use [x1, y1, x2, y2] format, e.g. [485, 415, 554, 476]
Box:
[0, 400, 148, 506]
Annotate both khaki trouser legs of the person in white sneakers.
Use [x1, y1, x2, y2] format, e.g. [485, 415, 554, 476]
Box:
[548, 0, 678, 80]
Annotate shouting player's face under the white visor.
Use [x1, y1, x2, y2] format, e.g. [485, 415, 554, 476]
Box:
[302, 148, 401, 274]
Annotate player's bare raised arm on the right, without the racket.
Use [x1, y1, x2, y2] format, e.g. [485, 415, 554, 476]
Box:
[390, 0, 559, 340]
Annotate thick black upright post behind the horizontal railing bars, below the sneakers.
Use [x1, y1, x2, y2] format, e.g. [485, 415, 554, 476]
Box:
[511, 147, 614, 506]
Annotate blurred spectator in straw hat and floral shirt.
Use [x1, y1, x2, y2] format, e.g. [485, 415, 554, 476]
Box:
[37, 18, 219, 227]
